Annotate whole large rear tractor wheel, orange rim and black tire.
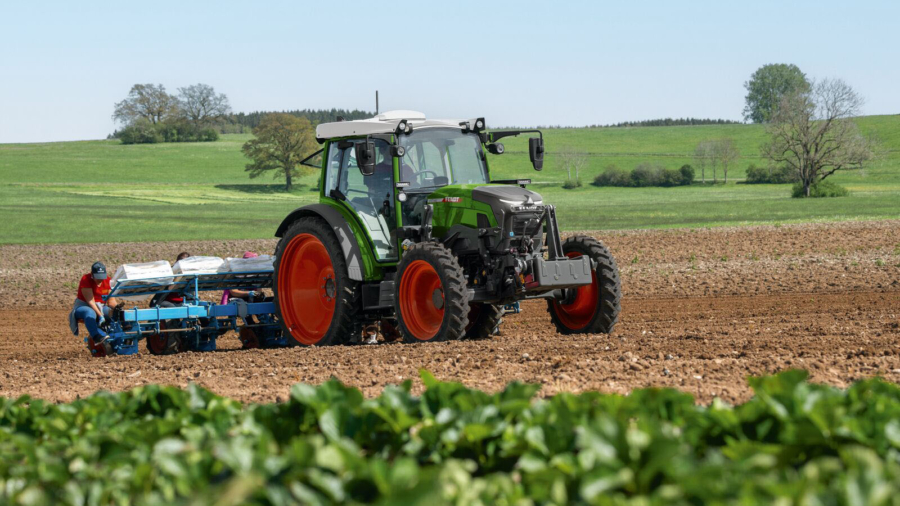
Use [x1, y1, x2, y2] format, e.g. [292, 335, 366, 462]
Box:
[274, 217, 361, 346]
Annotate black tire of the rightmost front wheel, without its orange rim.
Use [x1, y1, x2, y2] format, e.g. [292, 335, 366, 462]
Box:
[547, 235, 622, 334]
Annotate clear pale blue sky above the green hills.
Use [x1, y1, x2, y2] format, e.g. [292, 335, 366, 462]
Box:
[0, 0, 900, 143]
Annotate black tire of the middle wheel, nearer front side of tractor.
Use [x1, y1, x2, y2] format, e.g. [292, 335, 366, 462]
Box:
[394, 242, 469, 343]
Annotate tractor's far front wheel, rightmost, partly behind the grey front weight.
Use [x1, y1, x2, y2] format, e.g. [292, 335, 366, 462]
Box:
[547, 235, 622, 334]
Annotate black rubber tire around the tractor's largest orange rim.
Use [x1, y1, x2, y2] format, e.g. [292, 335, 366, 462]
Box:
[272, 217, 362, 346]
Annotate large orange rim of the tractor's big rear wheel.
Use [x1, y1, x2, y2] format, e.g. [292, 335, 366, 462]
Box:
[278, 234, 337, 345]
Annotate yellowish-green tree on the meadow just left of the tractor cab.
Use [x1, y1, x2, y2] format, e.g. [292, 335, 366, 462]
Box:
[241, 113, 318, 191]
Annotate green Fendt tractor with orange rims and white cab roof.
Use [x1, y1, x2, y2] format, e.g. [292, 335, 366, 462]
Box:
[274, 111, 621, 346]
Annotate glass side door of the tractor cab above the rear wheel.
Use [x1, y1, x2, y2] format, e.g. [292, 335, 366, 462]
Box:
[324, 139, 397, 261]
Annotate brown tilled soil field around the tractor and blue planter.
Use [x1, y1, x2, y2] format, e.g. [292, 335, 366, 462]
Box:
[0, 221, 900, 402]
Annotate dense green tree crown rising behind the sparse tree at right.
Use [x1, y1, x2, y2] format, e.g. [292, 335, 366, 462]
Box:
[744, 63, 809, 123]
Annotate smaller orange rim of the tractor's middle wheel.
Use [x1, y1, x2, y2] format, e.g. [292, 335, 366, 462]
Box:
[400, 260, 444, 341]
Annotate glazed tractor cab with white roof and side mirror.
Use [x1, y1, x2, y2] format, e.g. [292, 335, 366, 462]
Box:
[311, 111, 543, 262]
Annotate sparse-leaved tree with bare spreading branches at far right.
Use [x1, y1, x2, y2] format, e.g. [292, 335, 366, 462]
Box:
[762, 79, 874, 197]
